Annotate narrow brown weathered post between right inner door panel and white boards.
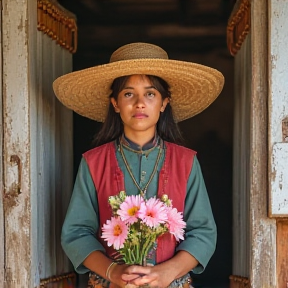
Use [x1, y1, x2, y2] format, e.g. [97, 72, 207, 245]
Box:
[249, 0, 277, 288]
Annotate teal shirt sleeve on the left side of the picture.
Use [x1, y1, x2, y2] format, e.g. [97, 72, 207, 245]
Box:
[61, 158, 105, 274]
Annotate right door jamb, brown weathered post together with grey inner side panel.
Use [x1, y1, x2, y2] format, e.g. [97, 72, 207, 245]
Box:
[231, 0, 277, 288]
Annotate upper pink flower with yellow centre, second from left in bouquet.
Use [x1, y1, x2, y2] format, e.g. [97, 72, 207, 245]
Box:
[117, 195, 145, 224]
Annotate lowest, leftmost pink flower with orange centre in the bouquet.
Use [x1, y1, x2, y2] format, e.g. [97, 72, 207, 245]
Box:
[101, 217, 128, 250]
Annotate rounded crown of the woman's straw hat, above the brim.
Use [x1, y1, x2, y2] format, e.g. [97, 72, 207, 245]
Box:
[110, 42, 168, 63]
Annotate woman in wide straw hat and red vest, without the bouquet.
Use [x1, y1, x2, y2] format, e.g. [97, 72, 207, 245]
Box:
[53, 43, 224, 287]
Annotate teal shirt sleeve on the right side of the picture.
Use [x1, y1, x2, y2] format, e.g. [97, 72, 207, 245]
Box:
[177, 156, 217, 274]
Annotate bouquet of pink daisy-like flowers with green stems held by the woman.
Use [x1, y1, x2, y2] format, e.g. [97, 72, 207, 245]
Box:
[101, 191, 186, 265]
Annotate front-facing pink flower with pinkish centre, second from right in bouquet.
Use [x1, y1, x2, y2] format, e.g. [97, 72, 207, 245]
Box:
[139, 197, 167, 228]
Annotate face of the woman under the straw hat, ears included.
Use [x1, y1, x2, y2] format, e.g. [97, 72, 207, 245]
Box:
[111, 75, 169, 139]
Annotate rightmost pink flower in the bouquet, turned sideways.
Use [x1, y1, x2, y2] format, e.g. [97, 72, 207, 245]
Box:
[166, 207, 186, 241]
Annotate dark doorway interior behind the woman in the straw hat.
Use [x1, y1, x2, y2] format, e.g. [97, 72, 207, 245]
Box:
[58, 0, 235, 288]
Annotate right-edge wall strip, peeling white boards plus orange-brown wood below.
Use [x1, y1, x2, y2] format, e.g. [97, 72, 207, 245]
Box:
[267, 0, 288, 288]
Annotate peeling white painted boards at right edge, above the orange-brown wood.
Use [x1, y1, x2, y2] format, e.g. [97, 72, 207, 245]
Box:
[268, 0, 288, 217]
